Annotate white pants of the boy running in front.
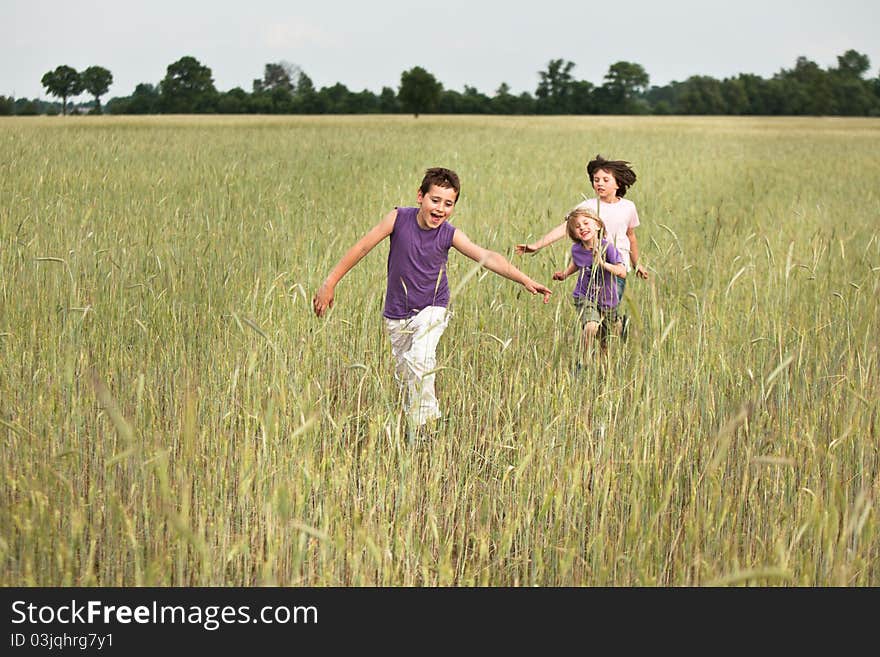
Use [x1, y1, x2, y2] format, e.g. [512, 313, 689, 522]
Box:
[385, 306, 449, 427]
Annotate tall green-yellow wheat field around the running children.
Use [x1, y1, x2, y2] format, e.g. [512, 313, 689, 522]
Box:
[0, 116, 880, 586]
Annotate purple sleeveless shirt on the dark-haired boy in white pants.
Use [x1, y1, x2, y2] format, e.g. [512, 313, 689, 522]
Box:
[382, 208, 455, 319]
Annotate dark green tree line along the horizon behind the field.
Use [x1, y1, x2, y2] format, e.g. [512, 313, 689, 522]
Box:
[0, 50, 880, 116]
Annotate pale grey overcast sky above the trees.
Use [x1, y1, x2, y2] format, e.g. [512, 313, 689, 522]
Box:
[0, 0, 880, 102]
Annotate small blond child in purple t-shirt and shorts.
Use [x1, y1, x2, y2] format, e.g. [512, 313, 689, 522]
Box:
[553, 207, 626, 351]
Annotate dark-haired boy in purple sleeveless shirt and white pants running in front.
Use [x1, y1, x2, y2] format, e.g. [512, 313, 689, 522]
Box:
[312, 167, 551, 439]
